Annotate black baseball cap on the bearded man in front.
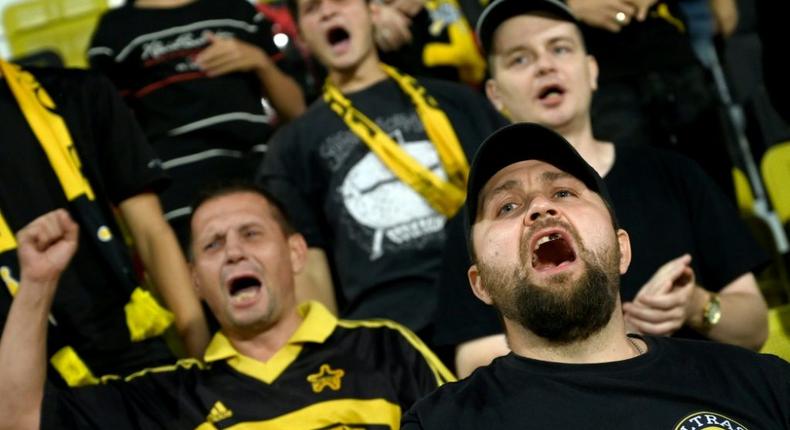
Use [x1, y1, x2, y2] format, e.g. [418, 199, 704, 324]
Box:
[466, 122, 617, 233]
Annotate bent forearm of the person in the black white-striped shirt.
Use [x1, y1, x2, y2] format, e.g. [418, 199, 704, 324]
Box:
[255, 58, 305, 121]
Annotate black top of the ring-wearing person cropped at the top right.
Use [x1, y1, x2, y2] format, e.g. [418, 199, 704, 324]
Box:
[581, 0, 698, 82]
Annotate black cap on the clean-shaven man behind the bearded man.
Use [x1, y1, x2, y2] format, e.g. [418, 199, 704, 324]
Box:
[475, 0, 579, 54]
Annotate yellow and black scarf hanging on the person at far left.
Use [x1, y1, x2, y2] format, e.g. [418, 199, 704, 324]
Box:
[0, 60, 173, 386]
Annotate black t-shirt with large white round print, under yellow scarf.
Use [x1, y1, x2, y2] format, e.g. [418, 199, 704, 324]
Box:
[260, 79, 504, 331]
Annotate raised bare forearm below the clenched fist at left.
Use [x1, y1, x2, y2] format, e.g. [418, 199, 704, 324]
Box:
[0, 277, 57, 430]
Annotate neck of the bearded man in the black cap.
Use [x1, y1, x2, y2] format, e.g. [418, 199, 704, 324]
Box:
[505, 305, 647, 364]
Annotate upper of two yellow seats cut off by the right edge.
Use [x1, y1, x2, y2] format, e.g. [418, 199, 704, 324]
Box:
[760, 142, 790, 225]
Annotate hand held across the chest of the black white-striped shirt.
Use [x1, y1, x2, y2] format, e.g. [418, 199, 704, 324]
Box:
[195, 33, 272, 77]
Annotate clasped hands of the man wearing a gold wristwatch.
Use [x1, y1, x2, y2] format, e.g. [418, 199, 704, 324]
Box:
[623, 254, 696, 336]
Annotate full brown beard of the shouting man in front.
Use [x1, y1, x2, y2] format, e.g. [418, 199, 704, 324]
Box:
[479, 224, 620, 344]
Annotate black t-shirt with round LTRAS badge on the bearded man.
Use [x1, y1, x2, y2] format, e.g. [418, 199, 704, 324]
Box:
[401, 337, 790, 430]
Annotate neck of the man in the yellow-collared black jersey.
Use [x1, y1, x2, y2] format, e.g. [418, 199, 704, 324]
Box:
[229, 309, 302, 362]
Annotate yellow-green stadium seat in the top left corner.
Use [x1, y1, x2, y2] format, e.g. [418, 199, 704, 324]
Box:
[3, 0, 107, 67]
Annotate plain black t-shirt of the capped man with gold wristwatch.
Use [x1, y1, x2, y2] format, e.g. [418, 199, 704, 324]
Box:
[435, 145, 767, 345]
